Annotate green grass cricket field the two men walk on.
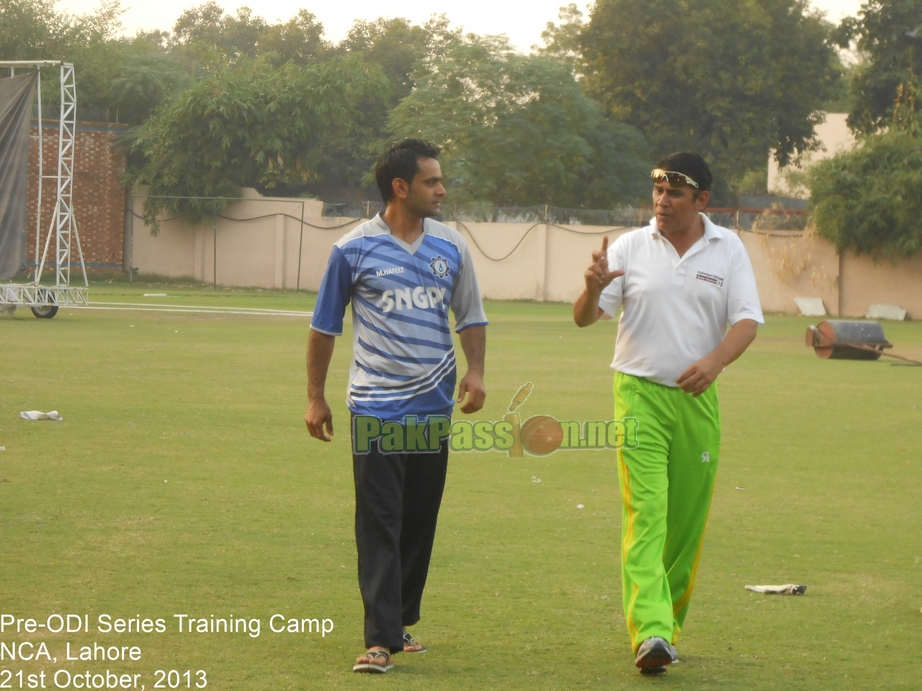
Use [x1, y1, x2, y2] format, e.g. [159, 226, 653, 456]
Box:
[0, 282, 922, 690]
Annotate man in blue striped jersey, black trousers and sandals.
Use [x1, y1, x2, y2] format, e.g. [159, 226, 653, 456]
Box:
[304, 139, 487, 673]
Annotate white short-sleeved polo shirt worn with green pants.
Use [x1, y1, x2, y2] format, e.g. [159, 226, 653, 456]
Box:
[599, 214, 764, 387]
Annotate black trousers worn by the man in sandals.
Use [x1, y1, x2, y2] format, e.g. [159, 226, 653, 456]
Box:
[352, 438, 448, 653]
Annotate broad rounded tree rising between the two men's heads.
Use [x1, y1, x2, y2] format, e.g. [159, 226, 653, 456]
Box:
[388, 36, 648, 208]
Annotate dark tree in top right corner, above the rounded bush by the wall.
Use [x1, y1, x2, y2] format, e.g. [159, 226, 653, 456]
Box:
[835, 0, 922, 134]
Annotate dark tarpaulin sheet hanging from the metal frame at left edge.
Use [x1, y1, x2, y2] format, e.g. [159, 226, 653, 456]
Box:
[0, 72, 38, 281]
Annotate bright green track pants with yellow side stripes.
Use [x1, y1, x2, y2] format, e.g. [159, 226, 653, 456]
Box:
[614, 372, 720, 652]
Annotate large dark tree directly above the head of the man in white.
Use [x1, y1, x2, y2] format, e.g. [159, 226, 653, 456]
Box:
[581, 0, 838, 203]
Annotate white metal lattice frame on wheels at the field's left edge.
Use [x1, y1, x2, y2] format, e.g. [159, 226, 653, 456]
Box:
[0, 60, 89, 318]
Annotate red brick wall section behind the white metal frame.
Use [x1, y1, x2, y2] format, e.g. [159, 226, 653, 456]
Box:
[26, 122, 126, 272]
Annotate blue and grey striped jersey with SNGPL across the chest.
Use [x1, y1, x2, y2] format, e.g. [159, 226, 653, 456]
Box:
[311, 215, 487, 422]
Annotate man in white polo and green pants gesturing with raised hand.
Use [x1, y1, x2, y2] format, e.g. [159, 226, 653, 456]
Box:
[573, 153, 763, 674]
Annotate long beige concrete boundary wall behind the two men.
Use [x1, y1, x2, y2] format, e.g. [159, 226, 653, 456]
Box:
[128, 190, 922, 319]
